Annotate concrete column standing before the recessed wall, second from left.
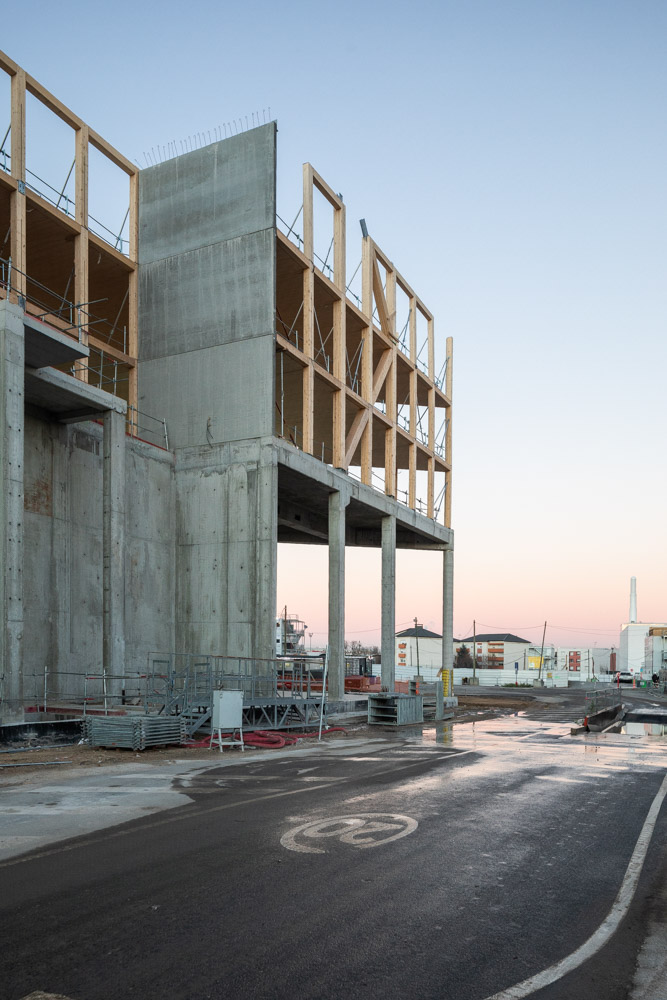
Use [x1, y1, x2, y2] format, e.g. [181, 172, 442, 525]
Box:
[102, 410, 126, 694]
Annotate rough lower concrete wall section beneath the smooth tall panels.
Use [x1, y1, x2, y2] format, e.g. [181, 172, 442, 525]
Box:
[176, 438, 278, 658]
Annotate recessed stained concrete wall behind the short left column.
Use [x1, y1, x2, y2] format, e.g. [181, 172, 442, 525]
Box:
[23, 414, 175, 695]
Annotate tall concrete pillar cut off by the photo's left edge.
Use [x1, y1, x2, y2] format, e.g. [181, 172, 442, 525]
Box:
[0, 301, 25, 722]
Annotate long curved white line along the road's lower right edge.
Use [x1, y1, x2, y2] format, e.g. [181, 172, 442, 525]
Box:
[486, 775, 667, 1000]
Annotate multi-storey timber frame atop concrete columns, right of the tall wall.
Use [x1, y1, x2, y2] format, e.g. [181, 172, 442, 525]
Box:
[276, 163, 452, 527]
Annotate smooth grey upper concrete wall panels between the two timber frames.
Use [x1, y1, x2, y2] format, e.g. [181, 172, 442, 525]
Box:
[138, 123, 276, 450]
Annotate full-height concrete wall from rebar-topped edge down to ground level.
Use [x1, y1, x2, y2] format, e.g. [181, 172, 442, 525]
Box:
[138, 129, 277, 658]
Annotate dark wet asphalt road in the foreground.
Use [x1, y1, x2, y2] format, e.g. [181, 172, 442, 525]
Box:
[0, 717, 667, 1000]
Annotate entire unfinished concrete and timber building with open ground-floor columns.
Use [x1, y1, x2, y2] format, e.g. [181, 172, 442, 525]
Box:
[0, 54, 453, 719]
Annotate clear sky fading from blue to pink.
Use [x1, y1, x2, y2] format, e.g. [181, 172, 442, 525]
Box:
[6, 0, 667, 645]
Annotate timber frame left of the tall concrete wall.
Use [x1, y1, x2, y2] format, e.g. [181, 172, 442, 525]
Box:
[0, 52, 139, 408]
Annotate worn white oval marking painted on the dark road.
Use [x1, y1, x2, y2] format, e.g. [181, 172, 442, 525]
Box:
[280, 813, 419, 854]
